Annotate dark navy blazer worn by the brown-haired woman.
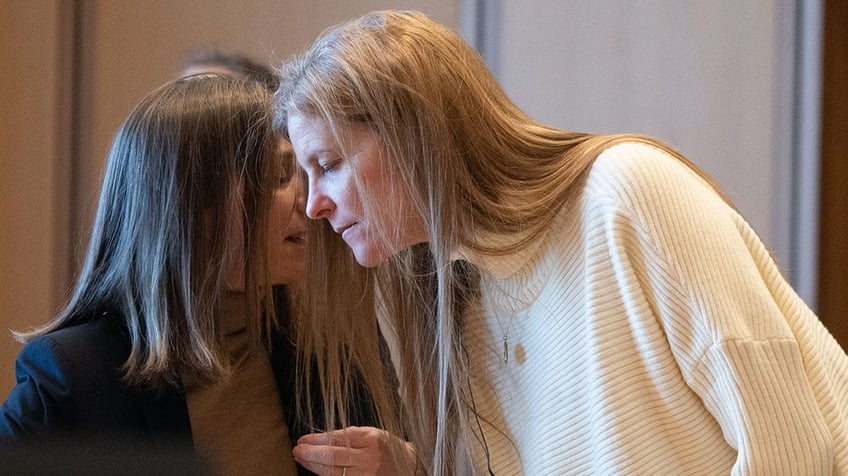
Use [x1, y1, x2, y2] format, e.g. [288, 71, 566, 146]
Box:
[0, 304, 374, 474]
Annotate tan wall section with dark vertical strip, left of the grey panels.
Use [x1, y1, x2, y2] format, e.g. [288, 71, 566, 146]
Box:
[0, 0, 459, 400]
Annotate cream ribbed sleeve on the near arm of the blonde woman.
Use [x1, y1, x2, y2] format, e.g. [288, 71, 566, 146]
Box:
[590, 143, 846, 474]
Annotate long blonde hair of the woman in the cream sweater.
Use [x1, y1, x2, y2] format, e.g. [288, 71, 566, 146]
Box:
[275, 11, 724, 474]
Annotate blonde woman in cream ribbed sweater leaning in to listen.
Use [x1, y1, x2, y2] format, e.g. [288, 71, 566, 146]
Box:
[275, 11, 848, 475]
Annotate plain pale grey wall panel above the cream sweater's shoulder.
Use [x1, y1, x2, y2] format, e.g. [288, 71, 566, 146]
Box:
[493, 0, 793, 265]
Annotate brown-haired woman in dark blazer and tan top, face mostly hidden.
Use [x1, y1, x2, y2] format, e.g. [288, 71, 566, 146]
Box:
[0, 74, 372, 474]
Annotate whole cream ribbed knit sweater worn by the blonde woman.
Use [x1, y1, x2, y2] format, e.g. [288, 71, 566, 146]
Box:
[464, 143, 848, 476]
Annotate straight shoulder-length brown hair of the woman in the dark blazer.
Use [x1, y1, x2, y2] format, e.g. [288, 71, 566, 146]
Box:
[17, 75, 294, 387]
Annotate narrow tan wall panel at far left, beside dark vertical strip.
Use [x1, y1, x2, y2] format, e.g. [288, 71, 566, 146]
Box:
[0, 0, 66, 398]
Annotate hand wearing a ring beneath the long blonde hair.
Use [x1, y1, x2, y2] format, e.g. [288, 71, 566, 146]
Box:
[292, 426, 415, 476]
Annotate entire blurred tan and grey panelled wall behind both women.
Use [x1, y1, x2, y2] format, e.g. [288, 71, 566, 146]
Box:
[0, 0, 848, 400]
